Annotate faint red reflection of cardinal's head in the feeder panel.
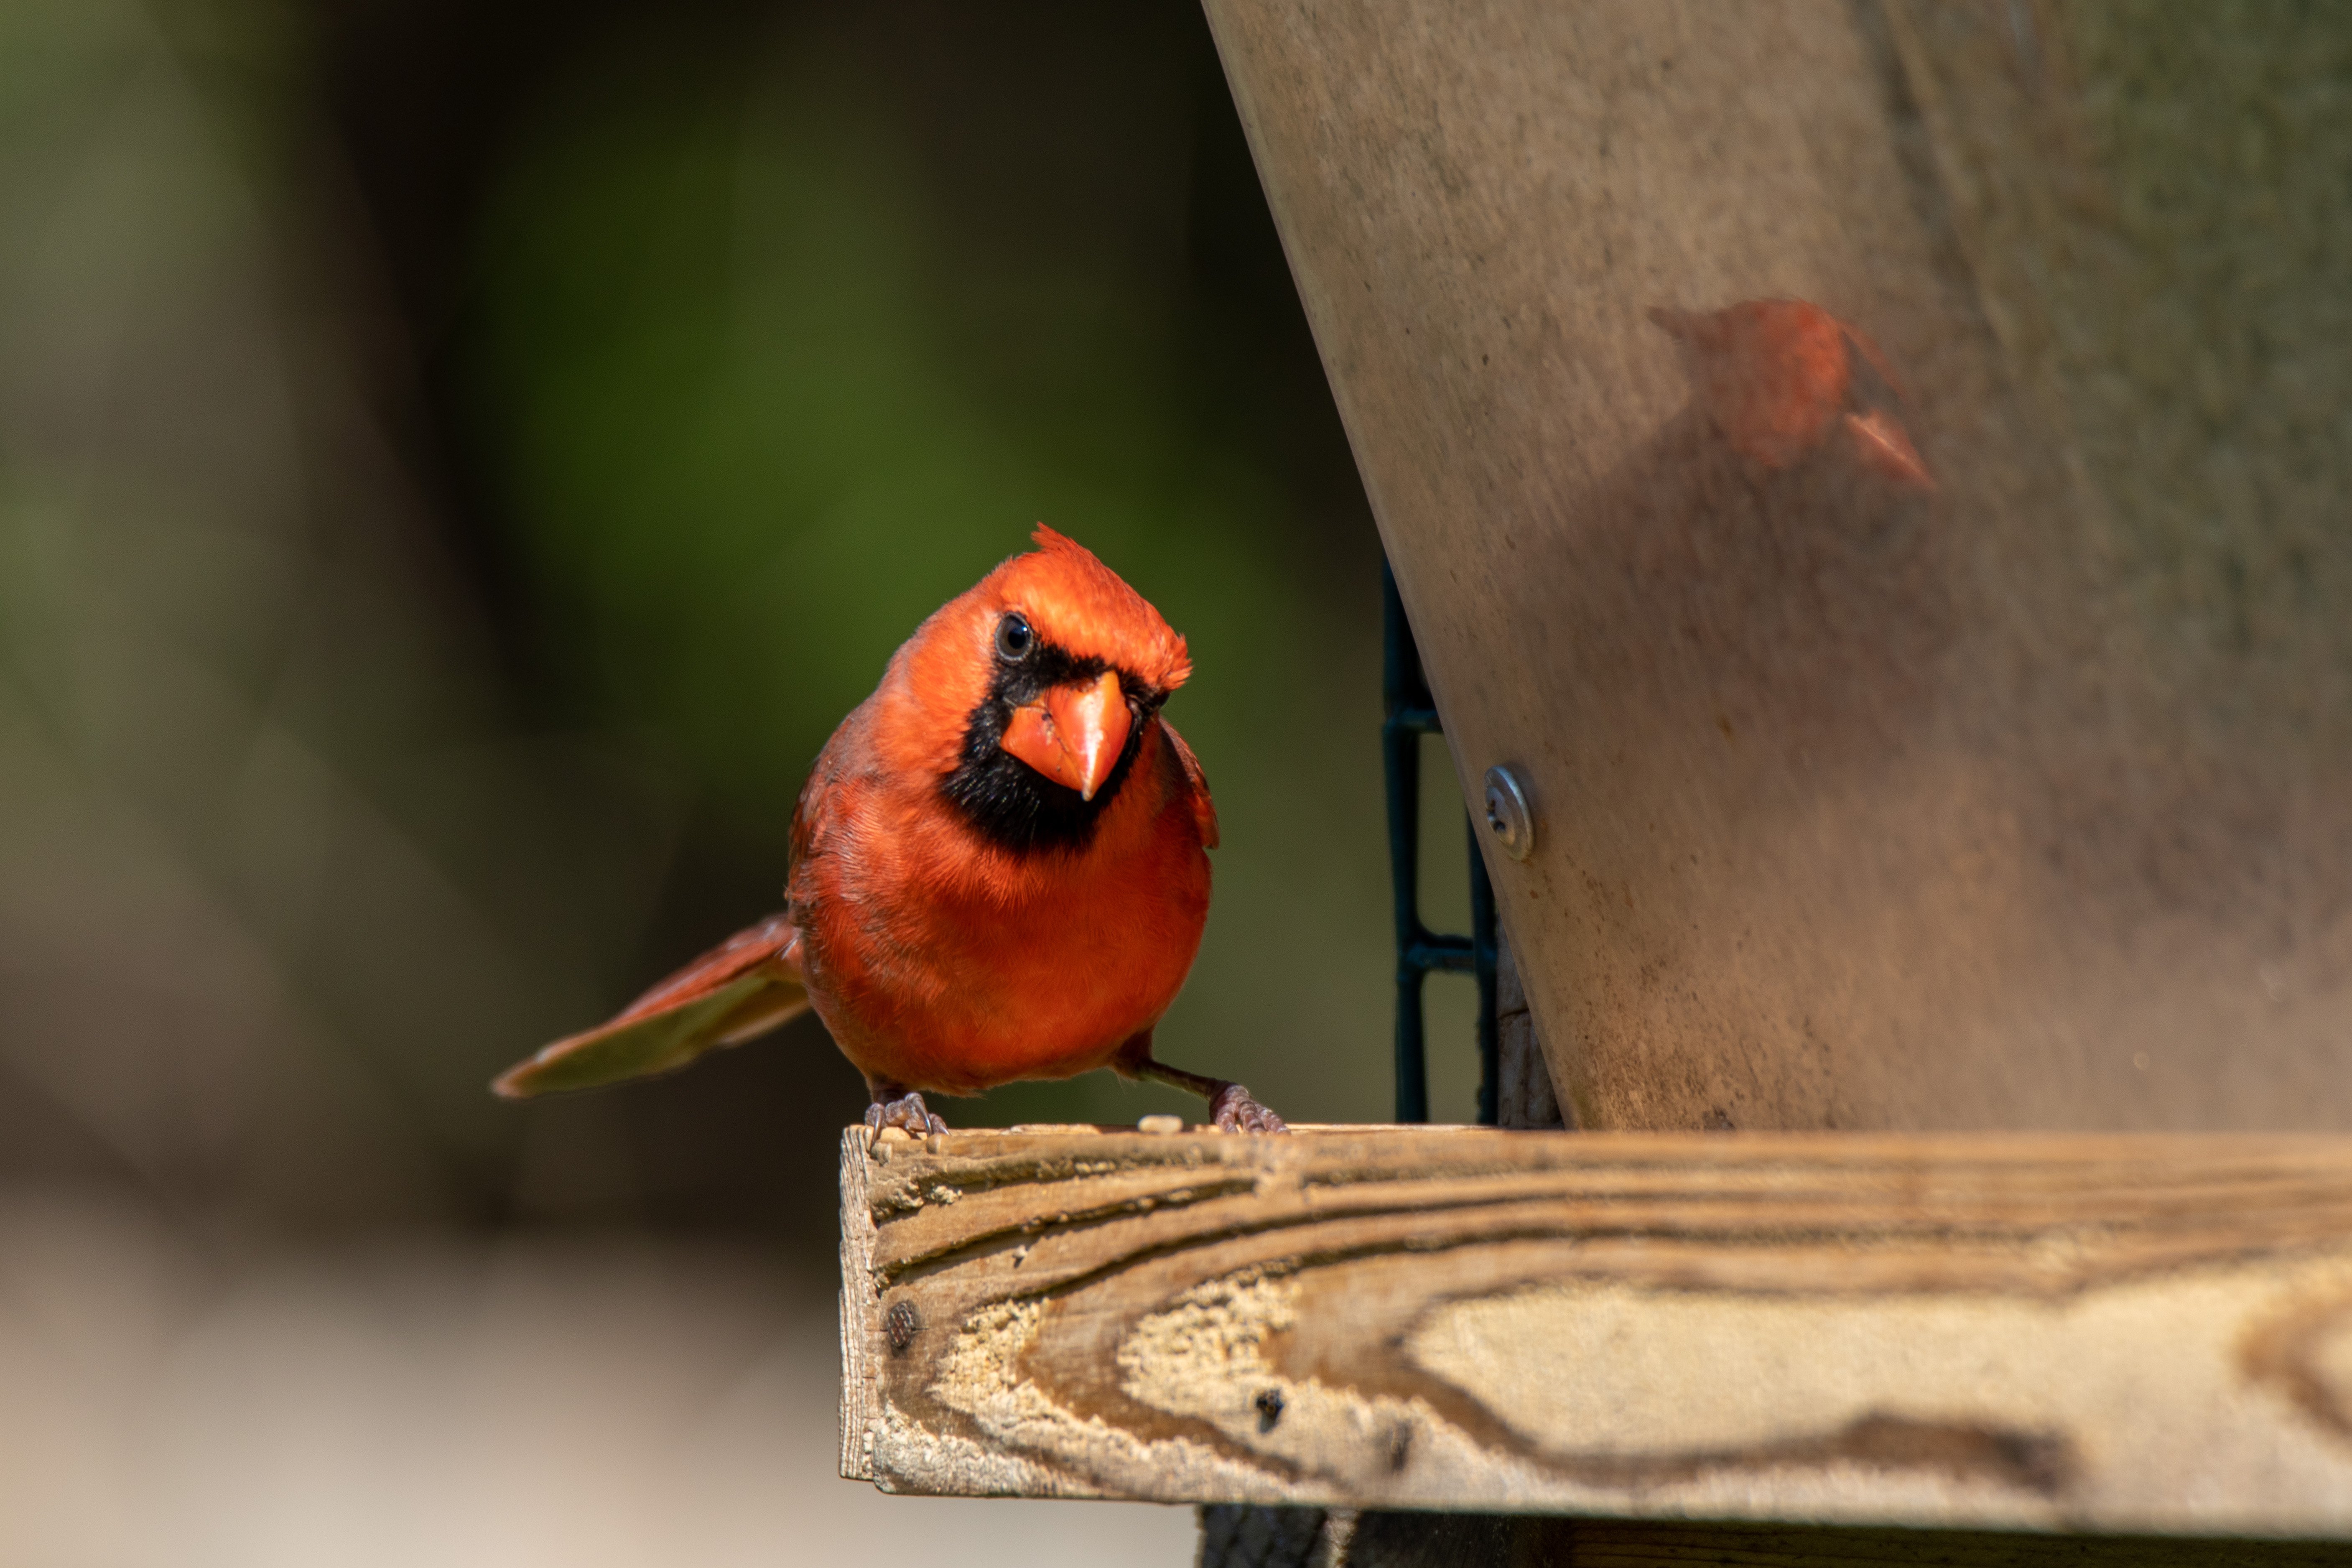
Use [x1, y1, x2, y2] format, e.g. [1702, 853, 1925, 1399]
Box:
[1649, 298, 1936, 489]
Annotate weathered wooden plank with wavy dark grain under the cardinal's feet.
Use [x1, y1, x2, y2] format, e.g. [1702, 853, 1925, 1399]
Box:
[842, 1128, 2352, 1535]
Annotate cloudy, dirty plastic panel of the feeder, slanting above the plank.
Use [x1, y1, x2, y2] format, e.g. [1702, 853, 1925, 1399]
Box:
[1207, 0, 2352, 1131]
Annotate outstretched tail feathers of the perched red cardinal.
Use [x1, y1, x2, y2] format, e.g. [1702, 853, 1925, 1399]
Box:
[492, 915, 809, 1100]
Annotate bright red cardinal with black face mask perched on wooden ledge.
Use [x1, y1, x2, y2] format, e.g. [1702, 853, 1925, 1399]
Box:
[496, 527, 1284, 1133]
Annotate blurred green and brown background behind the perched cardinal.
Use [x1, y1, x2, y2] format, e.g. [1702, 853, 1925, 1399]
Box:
[0, 0, 1475, 1563]
